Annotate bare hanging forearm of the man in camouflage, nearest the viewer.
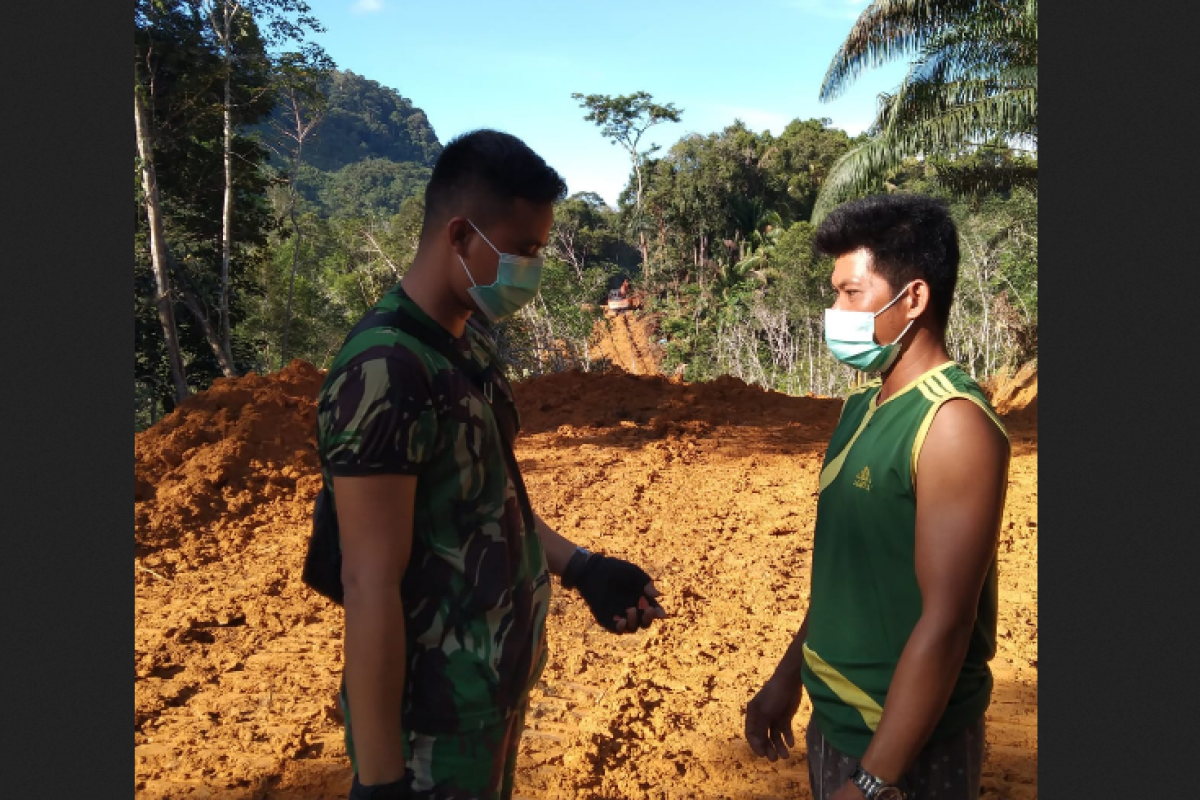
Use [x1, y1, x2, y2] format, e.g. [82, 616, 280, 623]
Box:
[344, 585, 406, 784]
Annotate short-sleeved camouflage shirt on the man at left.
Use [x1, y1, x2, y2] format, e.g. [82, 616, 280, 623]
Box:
[317, 284, 550, 733]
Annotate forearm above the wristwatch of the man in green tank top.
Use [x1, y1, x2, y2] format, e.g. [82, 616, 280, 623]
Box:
[863, 618, 971, 781]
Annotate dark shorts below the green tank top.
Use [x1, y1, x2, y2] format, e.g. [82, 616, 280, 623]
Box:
[805, 716, 984, 800]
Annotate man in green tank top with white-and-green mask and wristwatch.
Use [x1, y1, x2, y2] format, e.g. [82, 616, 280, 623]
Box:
[745, 194, 1009, 800]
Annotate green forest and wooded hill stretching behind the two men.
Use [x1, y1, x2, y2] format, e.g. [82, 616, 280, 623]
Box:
[134, 6, 1038, 428]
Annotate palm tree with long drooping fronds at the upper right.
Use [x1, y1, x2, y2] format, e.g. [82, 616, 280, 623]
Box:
[812, 0, 1038, 223]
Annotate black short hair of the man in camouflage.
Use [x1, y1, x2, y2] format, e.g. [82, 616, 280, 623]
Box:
[421, 130, 566, 236]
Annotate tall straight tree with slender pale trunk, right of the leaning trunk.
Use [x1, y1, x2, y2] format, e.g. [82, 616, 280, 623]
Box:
[200, 0, 324, 375]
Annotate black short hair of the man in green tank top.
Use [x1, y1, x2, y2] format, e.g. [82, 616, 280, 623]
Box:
[814, 193, 959, 329]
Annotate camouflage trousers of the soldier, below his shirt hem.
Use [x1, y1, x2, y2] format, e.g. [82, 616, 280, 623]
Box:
[337, 687, 528, 800]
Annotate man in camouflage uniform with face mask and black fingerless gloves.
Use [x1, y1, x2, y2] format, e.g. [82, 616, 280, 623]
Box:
[306, 131, 665, 800]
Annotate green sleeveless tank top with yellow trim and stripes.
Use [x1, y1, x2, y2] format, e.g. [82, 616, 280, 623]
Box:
[802, 362, 1008, 758]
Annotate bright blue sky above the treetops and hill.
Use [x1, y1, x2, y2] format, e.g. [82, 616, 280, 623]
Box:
[308, 0, 905, 204]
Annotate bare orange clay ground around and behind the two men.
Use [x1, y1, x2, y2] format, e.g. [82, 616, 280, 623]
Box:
[133, 362, 1038, 800]
